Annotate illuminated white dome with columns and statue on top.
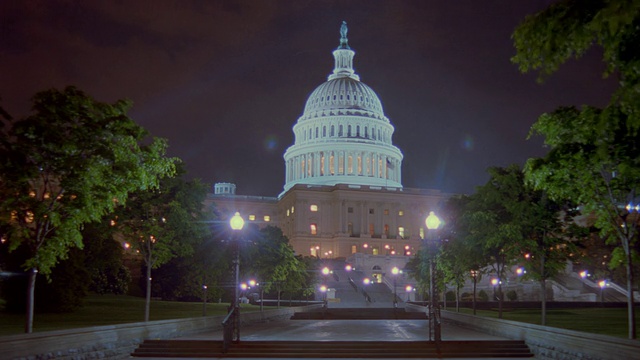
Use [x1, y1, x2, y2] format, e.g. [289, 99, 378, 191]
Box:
[284, 22, 403, 192]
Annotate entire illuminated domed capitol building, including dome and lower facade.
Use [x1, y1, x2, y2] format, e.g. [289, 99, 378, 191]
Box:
[207, 23, 446, 277]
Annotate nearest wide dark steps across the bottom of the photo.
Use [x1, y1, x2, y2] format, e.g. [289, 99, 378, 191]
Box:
[131, 340, 533, 359]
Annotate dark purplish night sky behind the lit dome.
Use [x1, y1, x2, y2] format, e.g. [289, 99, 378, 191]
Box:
[0, 0, 615, 196]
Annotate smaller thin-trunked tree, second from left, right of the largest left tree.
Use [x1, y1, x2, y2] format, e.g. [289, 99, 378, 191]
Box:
[118, 173, 210, 321]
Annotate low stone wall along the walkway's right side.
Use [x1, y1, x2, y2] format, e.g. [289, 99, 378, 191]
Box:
[411, 305, 640, 360]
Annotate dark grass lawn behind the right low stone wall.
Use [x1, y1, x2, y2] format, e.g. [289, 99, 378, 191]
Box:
[460, 307, 640, 338]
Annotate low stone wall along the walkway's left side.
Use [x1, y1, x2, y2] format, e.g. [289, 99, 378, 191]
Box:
[0, 305, 322, 360]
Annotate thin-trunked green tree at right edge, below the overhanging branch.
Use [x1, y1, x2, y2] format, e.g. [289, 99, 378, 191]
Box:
[525, 107, 640, 339]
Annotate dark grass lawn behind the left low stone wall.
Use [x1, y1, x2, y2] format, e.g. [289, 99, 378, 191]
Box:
[0, 295, 260, 336]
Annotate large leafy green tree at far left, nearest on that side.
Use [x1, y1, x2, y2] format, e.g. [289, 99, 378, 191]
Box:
[0, 87, 175, 333]
